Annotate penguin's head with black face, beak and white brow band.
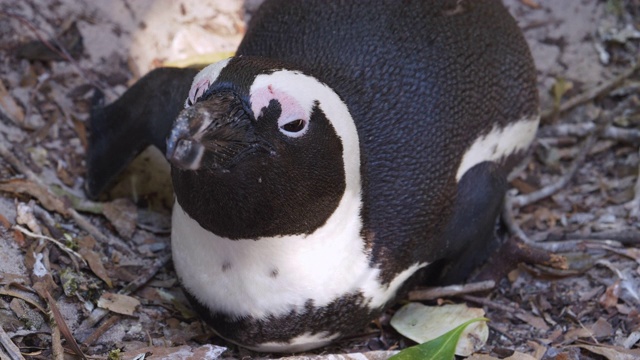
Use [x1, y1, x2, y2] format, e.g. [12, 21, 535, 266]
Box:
[167, 57, 360, 239]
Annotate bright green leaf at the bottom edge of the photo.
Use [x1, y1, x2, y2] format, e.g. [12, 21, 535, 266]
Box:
[389, 318, 489, 360]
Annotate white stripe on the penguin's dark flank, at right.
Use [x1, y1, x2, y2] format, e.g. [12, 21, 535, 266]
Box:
[456, 116, 540, 181]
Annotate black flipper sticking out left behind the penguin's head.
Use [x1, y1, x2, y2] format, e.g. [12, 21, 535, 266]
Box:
[85, 68, 198, 199]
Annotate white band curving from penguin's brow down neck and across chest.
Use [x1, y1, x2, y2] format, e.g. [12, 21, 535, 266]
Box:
[172, 70, 426, 330]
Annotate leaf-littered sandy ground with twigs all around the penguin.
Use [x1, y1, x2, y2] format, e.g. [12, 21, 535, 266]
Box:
[0, 0, 640, 359]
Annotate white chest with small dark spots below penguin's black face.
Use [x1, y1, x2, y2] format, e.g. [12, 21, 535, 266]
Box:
[172, 194, 427, 318]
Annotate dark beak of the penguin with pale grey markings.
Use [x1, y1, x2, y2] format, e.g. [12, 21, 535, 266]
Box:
[167, 91, 265, 170]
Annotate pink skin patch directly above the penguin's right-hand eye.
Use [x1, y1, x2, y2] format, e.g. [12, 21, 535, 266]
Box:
[251, 85, 309, 126]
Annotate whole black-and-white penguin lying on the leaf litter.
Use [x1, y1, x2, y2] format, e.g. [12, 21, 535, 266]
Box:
[87, 0, 539, 352]
